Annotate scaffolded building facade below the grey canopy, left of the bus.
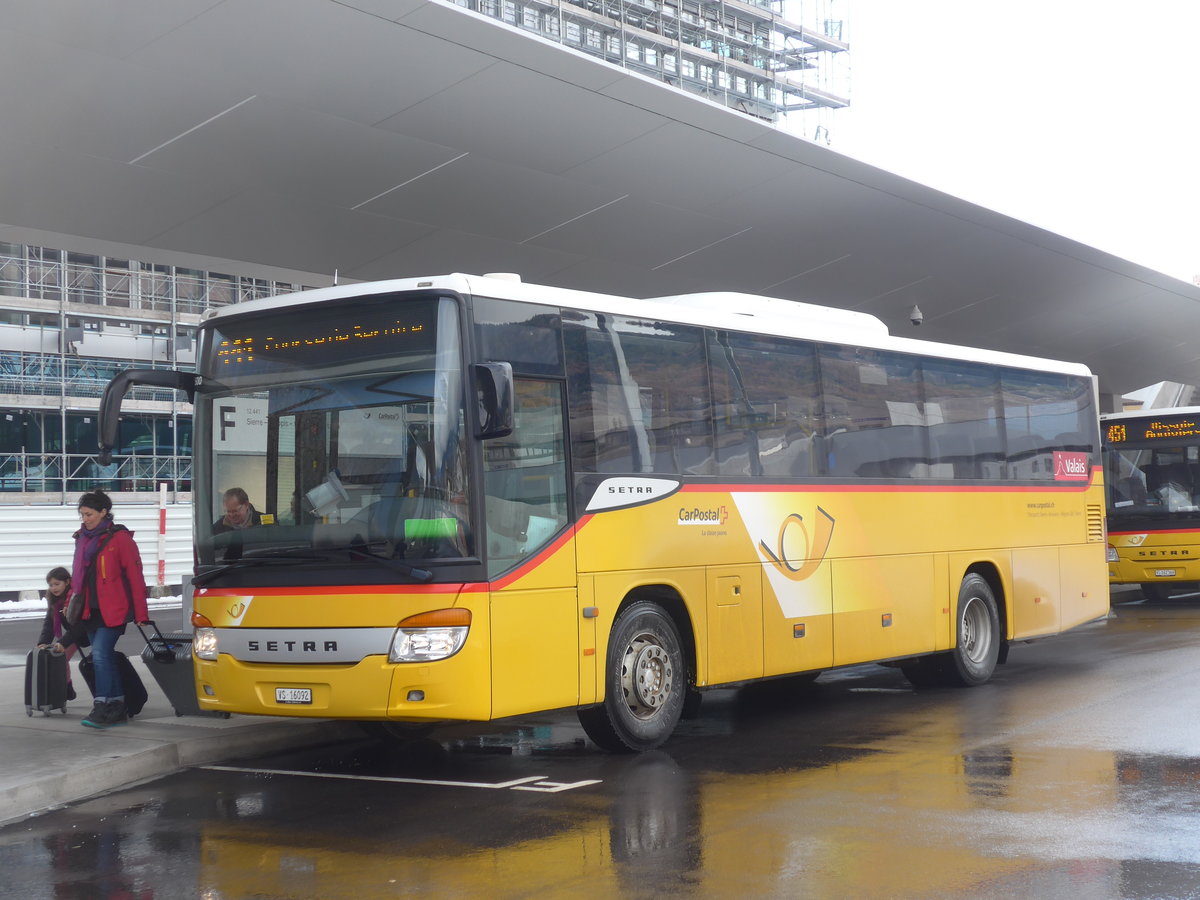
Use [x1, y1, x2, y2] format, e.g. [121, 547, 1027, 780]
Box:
[0, 242, 314, 503]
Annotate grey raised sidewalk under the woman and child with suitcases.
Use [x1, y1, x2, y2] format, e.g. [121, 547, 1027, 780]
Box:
[0, 655, 361, 826]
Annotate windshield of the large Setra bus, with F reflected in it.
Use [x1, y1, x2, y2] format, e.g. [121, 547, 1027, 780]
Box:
[196, 295, 473, 577]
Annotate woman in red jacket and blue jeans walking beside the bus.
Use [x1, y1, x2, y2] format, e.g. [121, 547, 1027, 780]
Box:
[71, 491, 150, 728]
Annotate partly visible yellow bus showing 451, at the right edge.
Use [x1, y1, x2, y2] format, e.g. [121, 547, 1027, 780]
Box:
[1100, 407, 1200, 601]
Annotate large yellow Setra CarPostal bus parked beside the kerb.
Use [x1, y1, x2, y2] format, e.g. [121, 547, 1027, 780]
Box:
[101, 275, 1108, 751]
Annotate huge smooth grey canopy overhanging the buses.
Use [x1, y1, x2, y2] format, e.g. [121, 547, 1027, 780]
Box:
[0, 0, 1200, 392]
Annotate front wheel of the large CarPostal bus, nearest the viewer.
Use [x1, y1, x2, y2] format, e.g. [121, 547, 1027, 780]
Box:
[578, 600, 688, 754]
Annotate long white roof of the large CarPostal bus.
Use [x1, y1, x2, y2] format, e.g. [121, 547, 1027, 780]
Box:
[205, 272, 1091, 377]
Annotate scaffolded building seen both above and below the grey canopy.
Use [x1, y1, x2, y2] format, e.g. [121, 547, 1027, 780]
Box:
[0, 0, 850, 505]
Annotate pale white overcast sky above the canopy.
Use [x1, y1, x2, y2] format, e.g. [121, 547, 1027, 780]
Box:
[804, 0, 1200, 281]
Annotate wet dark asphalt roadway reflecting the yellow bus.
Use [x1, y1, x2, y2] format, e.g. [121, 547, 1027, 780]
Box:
[7, 606, 1200, 900]
